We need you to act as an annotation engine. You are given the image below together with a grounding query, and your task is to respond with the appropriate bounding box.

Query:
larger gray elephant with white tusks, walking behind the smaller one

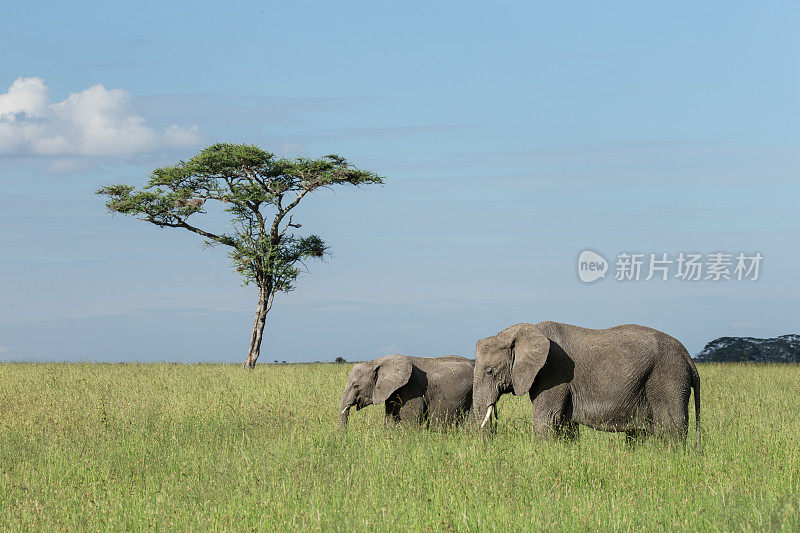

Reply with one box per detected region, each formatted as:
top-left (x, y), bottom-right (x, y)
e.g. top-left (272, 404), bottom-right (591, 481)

top-left (473, 322), bottom-right (700, 444)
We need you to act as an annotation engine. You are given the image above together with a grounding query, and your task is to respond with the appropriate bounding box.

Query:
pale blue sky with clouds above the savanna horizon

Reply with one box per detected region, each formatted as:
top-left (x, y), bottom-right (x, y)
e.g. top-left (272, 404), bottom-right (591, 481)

top-left (0, 2), bottom-right (800, 362)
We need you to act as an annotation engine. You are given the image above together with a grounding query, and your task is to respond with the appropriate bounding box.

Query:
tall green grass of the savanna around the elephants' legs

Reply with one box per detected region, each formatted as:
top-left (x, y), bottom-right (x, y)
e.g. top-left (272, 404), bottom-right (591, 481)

top-left (0, 364), bottom-right (800, 531)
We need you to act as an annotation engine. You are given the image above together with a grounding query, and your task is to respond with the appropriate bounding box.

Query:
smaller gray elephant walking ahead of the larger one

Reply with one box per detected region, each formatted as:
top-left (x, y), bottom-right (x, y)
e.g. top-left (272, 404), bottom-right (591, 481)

top-left (339, 355), bottom-right (474, 429)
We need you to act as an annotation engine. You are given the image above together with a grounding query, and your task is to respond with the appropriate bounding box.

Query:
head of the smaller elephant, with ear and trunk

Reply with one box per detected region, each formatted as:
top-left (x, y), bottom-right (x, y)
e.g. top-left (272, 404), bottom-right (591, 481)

top-left (339, 355), bottom-right (413, 429)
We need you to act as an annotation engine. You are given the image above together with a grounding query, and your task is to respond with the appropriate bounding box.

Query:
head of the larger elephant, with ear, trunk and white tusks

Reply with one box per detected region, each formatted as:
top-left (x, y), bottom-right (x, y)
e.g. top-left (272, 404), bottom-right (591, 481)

top-left (472, 324), bottom-right (550, 430)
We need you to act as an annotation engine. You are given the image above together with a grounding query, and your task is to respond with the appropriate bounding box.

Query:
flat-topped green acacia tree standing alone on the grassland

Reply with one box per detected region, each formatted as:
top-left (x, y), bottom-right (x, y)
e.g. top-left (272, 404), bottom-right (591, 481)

top-left (97, 144), bottom-right (383, 368)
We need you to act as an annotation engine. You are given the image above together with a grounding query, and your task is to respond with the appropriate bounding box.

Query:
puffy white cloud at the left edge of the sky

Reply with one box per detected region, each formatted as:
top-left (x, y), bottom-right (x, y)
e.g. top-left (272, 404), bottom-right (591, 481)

top-left (0, 78), bottom-right (200, 156)
